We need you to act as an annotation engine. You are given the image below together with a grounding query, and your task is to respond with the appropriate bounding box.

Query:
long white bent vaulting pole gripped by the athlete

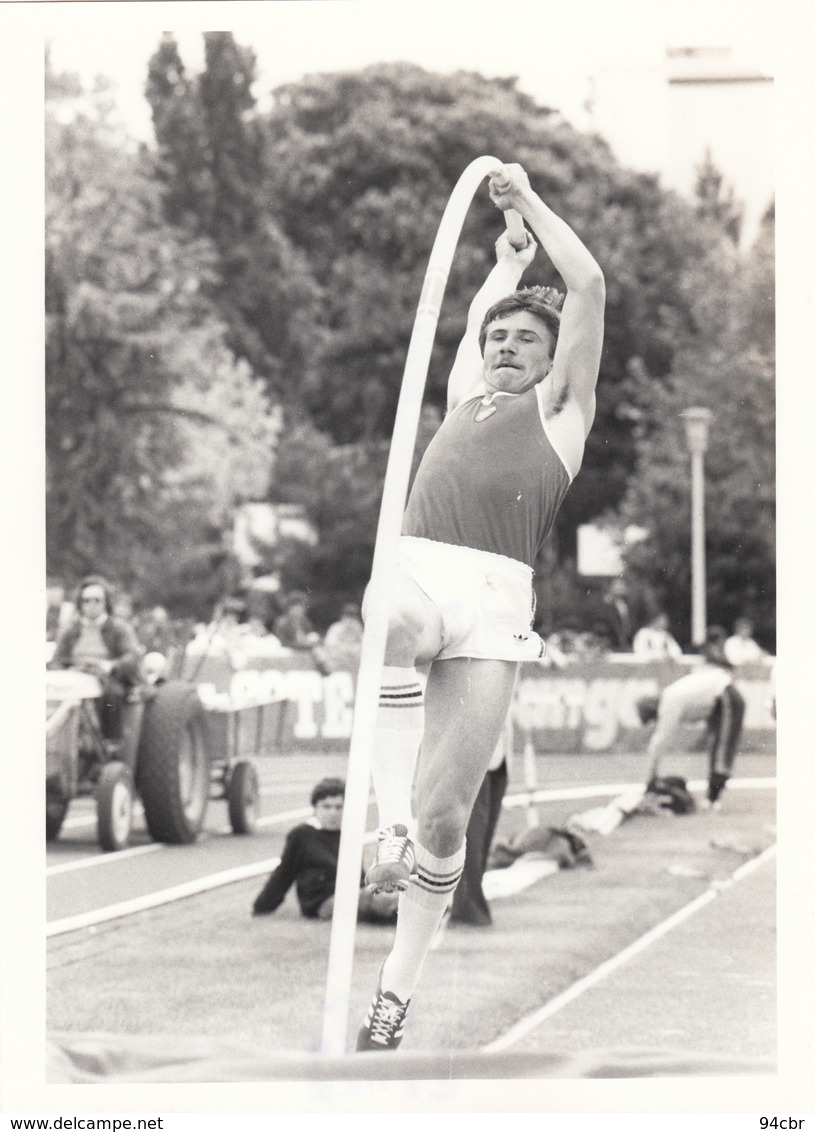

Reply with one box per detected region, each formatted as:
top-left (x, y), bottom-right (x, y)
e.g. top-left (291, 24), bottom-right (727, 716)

top-left (321, 157), bottom-right (526, 1057)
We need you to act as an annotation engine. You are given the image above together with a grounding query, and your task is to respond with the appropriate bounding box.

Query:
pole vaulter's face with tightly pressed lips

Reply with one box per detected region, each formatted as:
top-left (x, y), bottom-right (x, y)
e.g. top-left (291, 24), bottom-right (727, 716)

top-left (484, 310), bottom-right (552, 393)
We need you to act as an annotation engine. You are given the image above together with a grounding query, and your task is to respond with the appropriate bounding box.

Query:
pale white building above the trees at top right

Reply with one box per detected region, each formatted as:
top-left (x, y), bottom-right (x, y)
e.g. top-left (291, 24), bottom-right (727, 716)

top-left (590, 48), bottom-right (775, 246)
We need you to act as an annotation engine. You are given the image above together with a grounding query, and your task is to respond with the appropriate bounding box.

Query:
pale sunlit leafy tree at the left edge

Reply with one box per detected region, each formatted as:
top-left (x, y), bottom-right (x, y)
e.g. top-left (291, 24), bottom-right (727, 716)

top-left (45, 60), bottom-right (276, 611)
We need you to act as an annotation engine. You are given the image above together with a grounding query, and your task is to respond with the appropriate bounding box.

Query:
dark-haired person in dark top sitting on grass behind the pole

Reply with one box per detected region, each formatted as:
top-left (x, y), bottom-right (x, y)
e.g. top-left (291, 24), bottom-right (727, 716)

top-left (252, 778), bottom-right (398, 924)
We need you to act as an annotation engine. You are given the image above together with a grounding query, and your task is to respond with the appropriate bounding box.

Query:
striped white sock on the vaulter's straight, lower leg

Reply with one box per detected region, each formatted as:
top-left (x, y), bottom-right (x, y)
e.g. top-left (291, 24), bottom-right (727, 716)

top-left (381, 844), bottom-right (465, 1002)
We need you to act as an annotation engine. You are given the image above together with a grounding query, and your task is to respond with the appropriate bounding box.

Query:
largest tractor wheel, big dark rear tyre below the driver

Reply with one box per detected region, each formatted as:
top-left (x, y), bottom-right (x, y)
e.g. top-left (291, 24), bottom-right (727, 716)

top-left (136, 683), bottom-right (209, 844)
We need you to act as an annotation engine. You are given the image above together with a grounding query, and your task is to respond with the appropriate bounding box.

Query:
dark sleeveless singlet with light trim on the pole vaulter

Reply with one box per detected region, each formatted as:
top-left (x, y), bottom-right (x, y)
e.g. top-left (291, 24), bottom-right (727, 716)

top-left (402, 386), bottom-right (572, 568)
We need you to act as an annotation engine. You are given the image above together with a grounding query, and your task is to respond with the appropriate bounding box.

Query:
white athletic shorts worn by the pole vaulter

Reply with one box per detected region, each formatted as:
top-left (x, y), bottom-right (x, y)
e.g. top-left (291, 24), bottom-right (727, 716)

top-left (396, 535), bottom-right (544, 660)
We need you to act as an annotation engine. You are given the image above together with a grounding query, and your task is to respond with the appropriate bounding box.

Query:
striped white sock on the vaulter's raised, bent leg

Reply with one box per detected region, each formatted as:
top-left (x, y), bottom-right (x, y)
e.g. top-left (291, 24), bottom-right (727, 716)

top-left (371, 666), bottom-right (424, 831)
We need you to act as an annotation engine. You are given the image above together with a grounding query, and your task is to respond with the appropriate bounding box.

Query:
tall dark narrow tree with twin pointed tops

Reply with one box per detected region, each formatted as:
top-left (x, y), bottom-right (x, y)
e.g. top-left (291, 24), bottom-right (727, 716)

top-left (145, 32), bottom-right (316, 402)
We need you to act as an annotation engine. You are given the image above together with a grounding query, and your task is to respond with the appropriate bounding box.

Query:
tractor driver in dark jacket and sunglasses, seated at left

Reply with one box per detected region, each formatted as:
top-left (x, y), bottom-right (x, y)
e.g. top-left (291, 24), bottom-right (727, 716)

top-left (49, 574), bottom-right (144, 741)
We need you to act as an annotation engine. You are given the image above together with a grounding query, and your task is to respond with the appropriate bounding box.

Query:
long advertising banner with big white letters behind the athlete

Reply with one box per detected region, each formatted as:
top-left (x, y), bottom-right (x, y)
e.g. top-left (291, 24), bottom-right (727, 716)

top-left (182, 653), bottom-right (775, 755)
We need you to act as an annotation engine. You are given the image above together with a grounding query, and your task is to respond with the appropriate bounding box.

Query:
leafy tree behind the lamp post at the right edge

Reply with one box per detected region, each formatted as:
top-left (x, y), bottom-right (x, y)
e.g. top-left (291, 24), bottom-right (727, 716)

top-left (617, 202), bottom-right (775, 650)
